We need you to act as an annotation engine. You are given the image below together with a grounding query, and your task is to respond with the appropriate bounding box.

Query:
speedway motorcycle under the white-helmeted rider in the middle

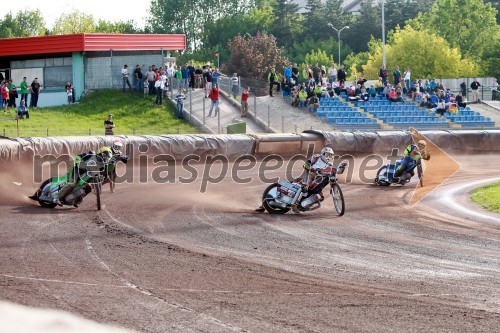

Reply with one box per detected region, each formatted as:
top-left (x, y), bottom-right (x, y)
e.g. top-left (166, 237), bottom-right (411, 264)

top-left (262, 163), bottom-right (347, 216)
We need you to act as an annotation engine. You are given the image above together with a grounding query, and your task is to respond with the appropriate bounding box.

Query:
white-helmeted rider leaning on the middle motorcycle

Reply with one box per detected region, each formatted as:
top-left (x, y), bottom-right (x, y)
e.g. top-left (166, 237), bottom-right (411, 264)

top-left (256, 147), bottom-right (334, 213)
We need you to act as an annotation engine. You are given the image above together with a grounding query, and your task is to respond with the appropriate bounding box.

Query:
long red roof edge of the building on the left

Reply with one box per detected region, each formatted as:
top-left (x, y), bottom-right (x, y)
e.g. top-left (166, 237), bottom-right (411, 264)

top-left (0, 34), bottom-right (186, 57)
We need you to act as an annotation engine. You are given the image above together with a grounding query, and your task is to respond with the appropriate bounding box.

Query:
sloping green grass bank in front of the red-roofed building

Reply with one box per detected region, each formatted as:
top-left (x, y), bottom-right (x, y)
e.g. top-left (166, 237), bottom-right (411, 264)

top-left (0, 90), bottom-right (200, 137)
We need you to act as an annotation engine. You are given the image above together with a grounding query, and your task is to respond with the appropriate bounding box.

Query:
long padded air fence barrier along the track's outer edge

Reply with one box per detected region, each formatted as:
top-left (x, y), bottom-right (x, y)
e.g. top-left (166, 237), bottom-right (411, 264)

top-left (0, 130), bottom-right (500, 164)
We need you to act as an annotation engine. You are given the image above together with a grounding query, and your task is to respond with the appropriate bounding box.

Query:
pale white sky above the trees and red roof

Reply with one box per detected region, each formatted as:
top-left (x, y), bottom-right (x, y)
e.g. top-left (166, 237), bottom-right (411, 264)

top-left (0, 0), bottom-right (151, 29)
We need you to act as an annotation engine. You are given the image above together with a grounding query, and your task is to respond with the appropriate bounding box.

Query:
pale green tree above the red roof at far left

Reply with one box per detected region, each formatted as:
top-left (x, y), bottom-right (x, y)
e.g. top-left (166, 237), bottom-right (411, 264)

top-left (0, 9), bottom-right (46, 38)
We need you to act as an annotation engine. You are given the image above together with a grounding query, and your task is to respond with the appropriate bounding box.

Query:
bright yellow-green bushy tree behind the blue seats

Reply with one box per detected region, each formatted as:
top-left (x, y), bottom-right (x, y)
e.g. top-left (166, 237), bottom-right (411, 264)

top-left (363, 26), bottom-right (479, 79)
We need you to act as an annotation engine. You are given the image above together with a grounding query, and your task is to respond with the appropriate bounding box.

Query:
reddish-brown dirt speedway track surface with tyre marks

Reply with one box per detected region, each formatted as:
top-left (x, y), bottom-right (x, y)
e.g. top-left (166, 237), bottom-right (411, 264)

top-left (0, 155), bottom-right (500, 332)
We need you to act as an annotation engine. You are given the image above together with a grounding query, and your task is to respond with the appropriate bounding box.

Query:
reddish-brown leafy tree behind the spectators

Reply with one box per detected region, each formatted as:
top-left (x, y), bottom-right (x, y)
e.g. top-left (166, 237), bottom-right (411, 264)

top-left (227, 32), bottom-right (288, 78)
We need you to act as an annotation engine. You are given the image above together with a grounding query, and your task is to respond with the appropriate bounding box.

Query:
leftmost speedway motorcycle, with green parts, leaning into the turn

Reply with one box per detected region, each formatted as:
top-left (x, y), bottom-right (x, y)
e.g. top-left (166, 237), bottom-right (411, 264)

top-left (29, 153), bottom-right (107, 210)
